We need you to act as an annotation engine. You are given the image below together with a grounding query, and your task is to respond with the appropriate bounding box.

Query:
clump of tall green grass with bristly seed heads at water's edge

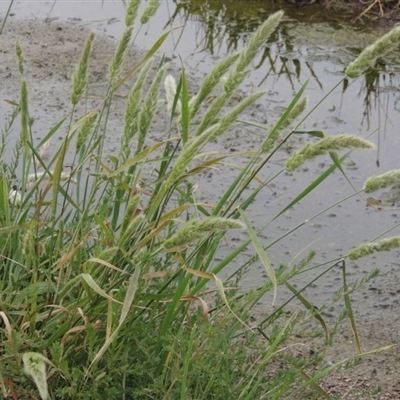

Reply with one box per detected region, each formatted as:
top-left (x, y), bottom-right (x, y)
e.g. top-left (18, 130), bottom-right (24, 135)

top-left (0, 0), bottom-right (398, 400)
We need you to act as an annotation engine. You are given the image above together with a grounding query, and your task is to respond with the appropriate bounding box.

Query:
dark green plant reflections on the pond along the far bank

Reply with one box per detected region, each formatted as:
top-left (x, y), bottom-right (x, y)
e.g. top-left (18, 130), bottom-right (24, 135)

top-left (167, 0), bottom-right (400, 141)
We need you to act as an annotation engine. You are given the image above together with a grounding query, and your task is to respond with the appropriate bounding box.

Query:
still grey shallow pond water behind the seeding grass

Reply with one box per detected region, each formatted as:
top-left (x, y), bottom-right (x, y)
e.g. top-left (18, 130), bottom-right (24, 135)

top-left (0, 0), bottom-right (400, 316)
